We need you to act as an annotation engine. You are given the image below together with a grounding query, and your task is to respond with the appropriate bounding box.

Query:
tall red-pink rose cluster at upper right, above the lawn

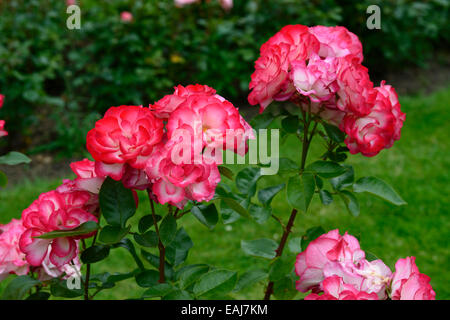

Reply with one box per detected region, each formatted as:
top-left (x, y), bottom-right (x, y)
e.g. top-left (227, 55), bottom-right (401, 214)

top-left (248, 25), bottom-right (405, 157)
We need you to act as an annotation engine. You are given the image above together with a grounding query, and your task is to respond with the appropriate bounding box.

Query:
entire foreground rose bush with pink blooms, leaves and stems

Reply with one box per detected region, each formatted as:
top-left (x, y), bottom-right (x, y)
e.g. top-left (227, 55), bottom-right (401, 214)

top-left (0, 24), bottom-right (435, 300)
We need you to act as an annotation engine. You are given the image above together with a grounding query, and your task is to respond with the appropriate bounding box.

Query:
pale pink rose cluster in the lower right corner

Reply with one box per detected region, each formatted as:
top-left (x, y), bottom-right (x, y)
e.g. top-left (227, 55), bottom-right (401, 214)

top-left (295, 230), bottom-right (436, 300)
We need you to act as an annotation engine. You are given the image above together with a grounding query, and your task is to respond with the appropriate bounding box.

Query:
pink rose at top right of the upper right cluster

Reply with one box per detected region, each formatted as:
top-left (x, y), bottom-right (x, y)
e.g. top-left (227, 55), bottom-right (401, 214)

top-left (309, 26), bottom-right (363, 63)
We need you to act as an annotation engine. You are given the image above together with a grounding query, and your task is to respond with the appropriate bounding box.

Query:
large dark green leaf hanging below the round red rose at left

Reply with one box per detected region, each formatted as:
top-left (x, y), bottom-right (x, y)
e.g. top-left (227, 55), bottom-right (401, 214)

top-left (99, 177), bottom-right (136, 228)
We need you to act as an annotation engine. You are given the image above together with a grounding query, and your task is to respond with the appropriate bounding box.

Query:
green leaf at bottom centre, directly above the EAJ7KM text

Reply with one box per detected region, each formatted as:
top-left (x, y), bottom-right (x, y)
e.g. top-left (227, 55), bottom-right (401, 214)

top-left (193, 270), bottom-right (237, 297)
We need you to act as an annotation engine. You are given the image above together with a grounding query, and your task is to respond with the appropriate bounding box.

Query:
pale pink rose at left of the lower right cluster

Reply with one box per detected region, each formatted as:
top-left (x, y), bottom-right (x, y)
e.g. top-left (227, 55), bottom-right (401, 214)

top-left (295, 229), bottom-right (365, 292)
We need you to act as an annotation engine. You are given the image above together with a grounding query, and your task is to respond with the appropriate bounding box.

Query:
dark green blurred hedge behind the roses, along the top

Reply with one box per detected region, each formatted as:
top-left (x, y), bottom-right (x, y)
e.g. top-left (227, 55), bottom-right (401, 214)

top-left (0, 0), bottom-right (450, 156)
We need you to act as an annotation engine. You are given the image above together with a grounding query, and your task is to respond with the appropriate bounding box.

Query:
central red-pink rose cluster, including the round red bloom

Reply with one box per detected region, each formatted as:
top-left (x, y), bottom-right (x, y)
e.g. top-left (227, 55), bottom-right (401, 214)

top-left (87, 84), bottom-right (253, 208)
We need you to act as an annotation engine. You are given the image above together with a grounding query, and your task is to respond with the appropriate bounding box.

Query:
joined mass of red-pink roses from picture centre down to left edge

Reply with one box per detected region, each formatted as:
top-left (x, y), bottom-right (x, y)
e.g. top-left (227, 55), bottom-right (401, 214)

top-left (0, 85), bottom-right (252, 275)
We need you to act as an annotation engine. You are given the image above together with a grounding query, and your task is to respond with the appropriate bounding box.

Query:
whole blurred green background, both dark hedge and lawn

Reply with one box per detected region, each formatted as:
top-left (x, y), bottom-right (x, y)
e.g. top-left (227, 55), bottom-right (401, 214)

top-left (0, 0), bottom-right (450, 299)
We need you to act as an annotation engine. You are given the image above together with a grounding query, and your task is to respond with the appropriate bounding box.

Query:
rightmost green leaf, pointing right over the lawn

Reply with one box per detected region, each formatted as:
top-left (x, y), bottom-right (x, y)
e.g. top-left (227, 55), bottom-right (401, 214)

top-left (353, 177), bottom-right (406, 206)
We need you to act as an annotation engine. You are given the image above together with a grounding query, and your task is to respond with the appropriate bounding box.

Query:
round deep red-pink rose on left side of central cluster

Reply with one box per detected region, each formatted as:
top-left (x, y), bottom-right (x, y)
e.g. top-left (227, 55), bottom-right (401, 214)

top-left (87, 106), bottom-right (163, 180)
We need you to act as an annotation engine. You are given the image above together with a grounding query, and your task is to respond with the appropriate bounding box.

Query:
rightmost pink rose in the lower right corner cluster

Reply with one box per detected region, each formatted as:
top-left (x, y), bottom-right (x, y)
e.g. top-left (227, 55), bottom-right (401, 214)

top-left (391, 257), bottom-right (436, 300)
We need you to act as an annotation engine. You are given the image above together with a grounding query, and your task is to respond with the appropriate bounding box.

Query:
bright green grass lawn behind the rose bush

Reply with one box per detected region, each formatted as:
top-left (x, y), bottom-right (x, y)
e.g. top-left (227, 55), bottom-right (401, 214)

top-left (0, 88), bottom-right (450, 299)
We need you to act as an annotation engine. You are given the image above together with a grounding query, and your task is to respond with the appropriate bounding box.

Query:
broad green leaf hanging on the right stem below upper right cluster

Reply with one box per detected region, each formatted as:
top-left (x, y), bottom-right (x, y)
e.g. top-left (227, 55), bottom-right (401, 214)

top-left (287, 172), bottom-right (316, 212)
